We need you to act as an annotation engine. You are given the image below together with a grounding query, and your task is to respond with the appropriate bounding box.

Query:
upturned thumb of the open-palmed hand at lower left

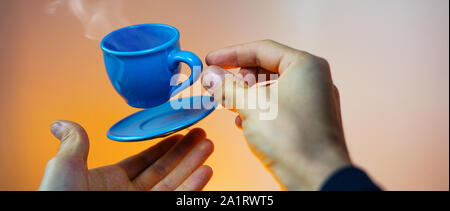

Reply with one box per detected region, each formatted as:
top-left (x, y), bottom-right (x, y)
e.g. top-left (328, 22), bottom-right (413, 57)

top-left (50, 120), bottom-right (89, 160)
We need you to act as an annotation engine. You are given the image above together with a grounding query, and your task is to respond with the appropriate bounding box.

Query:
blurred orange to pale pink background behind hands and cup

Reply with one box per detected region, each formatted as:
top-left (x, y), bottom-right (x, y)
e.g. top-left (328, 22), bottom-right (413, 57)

top-left (0, 0), bottom-right (449, 190)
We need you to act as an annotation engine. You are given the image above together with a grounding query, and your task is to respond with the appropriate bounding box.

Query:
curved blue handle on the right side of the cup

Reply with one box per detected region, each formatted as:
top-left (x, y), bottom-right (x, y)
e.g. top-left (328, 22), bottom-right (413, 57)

top-left (169, 51), bottom-right (203, 97)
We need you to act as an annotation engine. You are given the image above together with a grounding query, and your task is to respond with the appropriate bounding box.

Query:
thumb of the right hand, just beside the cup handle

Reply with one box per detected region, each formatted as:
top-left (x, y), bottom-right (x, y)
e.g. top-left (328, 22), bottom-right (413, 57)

top-left (202, 66), bottom-right (249, 117)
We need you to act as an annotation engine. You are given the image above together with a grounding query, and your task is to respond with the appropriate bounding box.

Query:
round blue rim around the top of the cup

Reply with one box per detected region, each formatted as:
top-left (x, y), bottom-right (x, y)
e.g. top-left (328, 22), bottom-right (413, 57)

top-left (100, 23), bottom-right (180, 56)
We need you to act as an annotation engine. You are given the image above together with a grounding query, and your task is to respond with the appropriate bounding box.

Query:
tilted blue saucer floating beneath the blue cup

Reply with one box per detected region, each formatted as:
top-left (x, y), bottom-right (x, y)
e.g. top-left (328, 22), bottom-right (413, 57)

top-left (107, 96), bottom-right (217, 142)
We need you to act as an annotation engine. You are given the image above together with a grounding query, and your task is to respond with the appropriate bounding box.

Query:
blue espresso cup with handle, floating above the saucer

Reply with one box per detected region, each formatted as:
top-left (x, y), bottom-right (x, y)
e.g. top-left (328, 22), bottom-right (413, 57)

top-left (100, 24), bottom-right (203, 108)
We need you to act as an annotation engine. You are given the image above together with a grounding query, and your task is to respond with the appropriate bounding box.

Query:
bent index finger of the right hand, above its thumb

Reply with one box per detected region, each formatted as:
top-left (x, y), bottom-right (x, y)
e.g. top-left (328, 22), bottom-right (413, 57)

top-left (205, 40), bottom-right (307, 74)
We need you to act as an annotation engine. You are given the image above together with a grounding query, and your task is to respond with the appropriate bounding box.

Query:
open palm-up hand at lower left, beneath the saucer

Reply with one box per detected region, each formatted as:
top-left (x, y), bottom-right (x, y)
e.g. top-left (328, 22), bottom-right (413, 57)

top-left (39, 121), bottom-right (213, 191)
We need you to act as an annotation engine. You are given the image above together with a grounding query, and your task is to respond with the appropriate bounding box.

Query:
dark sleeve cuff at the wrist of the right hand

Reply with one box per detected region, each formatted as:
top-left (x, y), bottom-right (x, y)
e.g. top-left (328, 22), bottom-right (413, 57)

top-left (320, 166), bottom-right (381, 191)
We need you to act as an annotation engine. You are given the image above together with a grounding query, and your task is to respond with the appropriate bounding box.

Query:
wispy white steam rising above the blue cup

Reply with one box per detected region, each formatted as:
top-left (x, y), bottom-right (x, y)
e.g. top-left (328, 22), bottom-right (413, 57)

top-left (46, 0), bottom-right (130, 40)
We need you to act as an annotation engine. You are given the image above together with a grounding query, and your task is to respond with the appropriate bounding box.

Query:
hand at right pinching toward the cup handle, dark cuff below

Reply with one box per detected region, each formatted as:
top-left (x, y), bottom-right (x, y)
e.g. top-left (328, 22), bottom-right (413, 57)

top-left (202, 40), bottom-right (351, 190)
